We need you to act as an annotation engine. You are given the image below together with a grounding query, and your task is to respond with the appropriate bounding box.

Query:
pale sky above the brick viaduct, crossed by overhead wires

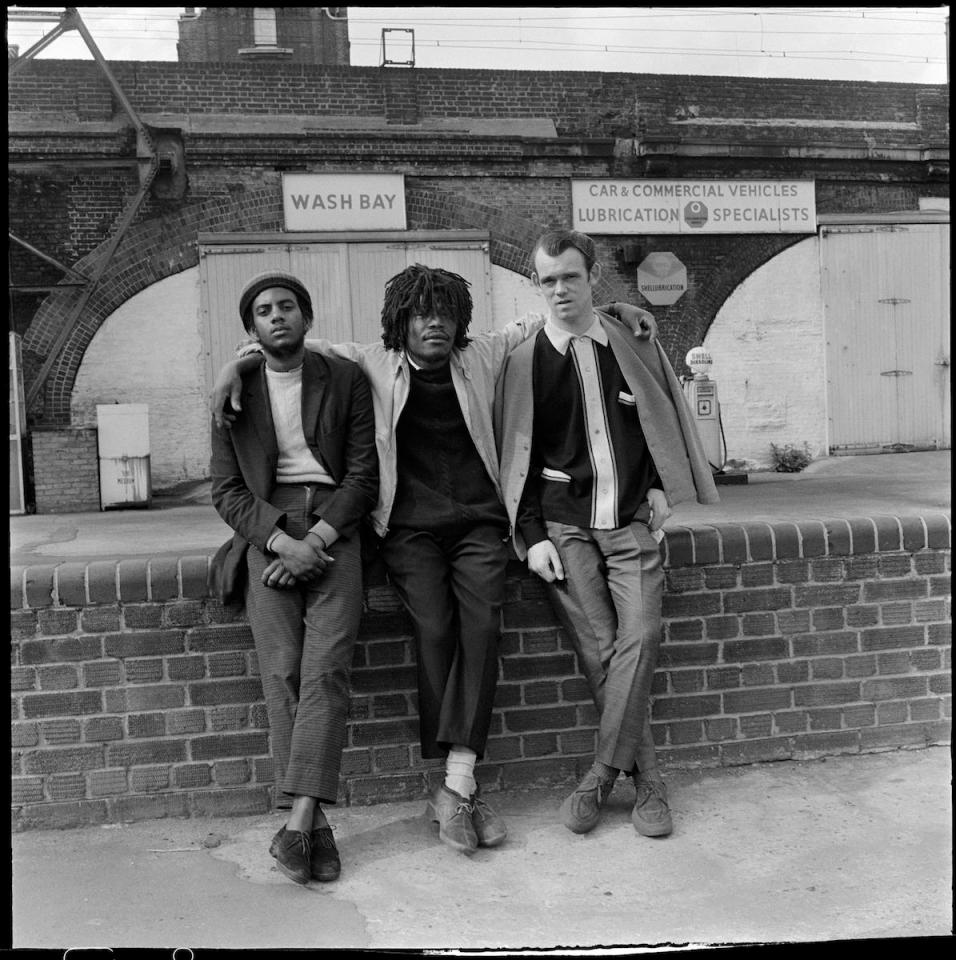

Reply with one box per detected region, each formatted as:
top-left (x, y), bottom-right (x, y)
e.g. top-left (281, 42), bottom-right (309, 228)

top-left (7, 6), bottom-right (949, 83)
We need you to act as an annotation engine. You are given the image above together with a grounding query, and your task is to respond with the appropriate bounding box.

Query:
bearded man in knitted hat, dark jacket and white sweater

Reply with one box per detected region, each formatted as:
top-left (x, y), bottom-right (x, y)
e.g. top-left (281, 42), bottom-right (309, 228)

top-left (210, 270), bottom-right (378, 883)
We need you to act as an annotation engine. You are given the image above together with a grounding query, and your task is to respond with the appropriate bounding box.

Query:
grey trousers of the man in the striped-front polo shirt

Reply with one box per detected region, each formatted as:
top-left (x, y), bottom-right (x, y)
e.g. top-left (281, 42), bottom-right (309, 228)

top-left (547, 520), bottom-right (664, 775)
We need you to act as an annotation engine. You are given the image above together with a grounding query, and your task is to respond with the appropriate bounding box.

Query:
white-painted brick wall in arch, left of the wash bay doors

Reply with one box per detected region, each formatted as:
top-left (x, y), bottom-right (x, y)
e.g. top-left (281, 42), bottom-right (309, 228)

top-left (70, 268), bottom-right (209, 490)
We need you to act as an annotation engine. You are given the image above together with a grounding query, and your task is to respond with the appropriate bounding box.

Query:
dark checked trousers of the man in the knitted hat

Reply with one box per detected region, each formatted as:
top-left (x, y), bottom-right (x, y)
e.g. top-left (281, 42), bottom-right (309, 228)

top-left (246, 485), bottom-right (362, 803)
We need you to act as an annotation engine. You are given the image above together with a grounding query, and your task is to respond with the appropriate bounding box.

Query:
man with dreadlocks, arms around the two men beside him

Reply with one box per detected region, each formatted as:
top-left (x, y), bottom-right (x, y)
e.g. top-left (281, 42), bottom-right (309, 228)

top-left (212, 263), bottom-right (656, 853)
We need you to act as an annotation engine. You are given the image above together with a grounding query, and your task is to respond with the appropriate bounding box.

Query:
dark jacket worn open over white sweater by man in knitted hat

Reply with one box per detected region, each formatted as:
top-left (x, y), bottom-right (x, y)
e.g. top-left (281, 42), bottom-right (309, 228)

top-left (210, 351), bottom-right (378, 576)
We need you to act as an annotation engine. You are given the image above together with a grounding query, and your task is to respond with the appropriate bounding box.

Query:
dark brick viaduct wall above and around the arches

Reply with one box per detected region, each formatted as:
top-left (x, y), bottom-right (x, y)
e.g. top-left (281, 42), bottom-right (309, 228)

top-left (14, 60), bottom-right (948, 427)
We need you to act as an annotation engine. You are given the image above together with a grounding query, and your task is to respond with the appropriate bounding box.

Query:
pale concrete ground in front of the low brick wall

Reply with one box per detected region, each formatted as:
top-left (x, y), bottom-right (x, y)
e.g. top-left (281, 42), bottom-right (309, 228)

top-left (12, 747), bottom-right (953, 955)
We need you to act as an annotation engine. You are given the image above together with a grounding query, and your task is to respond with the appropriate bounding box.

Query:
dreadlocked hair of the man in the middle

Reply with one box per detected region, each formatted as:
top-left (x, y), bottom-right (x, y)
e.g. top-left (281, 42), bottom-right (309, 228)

top-left (382, 263), bottom-right (472, 350)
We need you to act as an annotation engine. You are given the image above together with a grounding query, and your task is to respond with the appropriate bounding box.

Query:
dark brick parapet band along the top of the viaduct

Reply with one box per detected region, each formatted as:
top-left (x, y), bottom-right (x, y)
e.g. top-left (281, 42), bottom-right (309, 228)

top-left (8, 60), bottom-right (947, 142)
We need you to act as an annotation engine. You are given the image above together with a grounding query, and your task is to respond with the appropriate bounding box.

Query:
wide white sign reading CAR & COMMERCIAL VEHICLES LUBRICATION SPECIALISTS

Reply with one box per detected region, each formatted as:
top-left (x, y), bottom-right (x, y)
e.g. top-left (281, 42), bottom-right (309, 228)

top-left (571, 180), bottom-right (817, 234)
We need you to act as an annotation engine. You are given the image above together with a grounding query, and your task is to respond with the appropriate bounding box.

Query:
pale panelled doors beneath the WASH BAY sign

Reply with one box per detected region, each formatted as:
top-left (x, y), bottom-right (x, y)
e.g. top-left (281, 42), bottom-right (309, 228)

top-left (199, 240), bottom-right (492, 390)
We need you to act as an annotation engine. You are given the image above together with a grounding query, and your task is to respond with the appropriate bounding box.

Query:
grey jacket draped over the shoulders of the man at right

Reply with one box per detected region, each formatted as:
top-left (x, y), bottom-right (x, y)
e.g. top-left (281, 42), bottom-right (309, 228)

top-left (495, 313), bottom-right (719, 560)
